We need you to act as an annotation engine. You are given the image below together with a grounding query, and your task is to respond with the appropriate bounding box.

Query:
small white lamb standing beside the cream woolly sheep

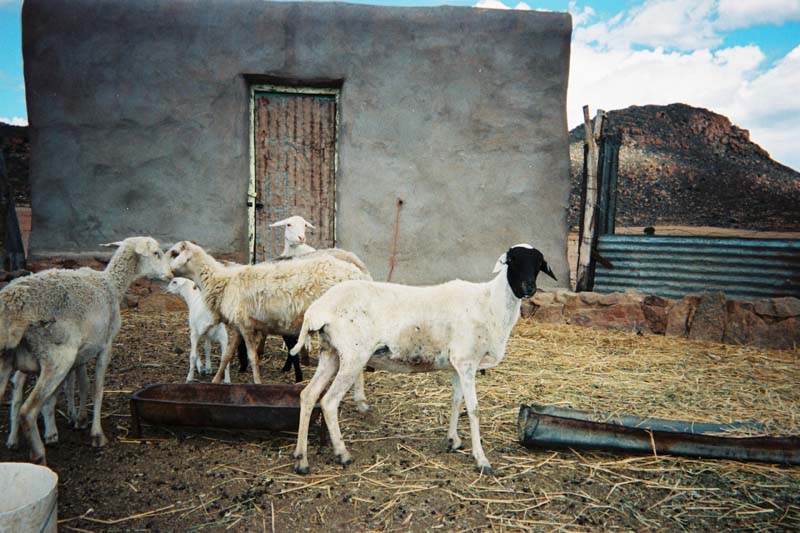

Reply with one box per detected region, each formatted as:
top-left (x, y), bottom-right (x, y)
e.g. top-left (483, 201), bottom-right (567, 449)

top-left (166, 278), bottom-right (231, 383)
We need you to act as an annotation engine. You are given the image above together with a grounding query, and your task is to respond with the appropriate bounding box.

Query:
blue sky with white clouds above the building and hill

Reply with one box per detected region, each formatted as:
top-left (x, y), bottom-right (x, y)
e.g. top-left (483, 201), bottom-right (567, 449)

top-left (0, 0), bottom-right (800, 171)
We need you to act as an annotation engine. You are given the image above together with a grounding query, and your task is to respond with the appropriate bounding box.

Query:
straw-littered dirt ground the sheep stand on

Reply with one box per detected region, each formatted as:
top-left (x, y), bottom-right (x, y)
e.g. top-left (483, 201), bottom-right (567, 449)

top-left (0, 311), bottom-right (800, 532)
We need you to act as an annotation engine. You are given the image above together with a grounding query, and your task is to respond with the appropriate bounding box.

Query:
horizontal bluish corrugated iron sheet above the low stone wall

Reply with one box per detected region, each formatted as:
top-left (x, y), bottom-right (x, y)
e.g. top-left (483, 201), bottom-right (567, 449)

top-left (594, 235), bottom-right (800, 299)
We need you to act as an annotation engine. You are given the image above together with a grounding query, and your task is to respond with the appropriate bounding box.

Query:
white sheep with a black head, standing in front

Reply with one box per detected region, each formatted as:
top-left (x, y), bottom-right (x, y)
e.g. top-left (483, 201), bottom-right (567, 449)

top-left (292, 244), bottom-right (555, 474)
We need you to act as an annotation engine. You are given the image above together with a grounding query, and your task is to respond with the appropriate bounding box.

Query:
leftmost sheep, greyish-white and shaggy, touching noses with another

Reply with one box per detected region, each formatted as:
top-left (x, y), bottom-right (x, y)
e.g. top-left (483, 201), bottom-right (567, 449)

top-left (0, 237), bottom-right (170, 464)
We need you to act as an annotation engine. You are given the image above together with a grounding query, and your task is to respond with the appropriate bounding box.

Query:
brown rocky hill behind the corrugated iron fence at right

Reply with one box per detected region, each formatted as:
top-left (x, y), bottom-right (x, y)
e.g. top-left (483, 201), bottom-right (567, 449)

top-left (569, 104), bottom-right (800, 231)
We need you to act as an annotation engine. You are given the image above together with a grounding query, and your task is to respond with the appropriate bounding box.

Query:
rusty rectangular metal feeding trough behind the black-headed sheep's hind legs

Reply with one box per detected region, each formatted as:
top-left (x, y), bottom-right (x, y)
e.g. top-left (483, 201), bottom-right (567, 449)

top-left (130, 383), bottom-right (325, 437)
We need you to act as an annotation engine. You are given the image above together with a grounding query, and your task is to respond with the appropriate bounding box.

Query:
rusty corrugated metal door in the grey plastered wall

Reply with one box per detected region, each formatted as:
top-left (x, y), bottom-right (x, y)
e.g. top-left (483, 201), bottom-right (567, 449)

top-left (253, 91), bottom-right (336, 261)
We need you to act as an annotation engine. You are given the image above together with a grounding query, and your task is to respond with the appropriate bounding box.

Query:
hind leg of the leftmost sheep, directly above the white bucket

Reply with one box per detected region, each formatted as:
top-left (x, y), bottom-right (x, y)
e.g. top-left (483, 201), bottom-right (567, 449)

top-left (19, 356), bottom-right (77, 464)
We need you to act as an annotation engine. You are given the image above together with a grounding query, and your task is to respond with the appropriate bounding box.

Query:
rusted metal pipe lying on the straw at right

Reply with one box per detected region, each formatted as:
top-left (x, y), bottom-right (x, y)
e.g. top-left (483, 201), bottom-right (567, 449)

top-left (517, 405), bottom-right (800, 465)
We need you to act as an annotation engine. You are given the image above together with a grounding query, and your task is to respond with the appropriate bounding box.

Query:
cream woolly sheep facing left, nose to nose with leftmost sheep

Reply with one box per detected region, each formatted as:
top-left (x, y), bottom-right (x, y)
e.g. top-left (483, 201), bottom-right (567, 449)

top-left (168, 241), bottom-right (372, 411)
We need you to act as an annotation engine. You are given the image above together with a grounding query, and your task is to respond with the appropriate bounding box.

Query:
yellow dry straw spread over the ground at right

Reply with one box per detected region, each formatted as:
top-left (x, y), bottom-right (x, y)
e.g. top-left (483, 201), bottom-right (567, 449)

top-left (186, 322), bottom-right (800, 531)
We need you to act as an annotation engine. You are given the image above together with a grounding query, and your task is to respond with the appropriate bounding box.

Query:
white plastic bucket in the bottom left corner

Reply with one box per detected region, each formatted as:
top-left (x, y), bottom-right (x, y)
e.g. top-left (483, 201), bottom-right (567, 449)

top-left (0, 463), bottom-right (58, 533)
